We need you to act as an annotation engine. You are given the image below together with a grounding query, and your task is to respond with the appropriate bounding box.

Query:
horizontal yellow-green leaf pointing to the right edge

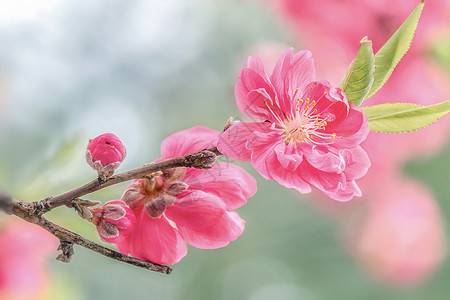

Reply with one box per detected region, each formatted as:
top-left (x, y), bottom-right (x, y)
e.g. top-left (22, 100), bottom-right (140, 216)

top-left (363, 100), bottom-right (450, 133)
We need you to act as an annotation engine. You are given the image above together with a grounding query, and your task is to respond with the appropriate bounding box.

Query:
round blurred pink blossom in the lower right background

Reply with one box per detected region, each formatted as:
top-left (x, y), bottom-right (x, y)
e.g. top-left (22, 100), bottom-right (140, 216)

top-left (349, 180), bottom-right (445, 286)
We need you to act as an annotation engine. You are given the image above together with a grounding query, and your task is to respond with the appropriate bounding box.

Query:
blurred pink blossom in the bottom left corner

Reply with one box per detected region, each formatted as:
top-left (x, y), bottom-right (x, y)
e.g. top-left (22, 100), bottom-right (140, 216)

top-left (0, 221), bottom-right (58, 300)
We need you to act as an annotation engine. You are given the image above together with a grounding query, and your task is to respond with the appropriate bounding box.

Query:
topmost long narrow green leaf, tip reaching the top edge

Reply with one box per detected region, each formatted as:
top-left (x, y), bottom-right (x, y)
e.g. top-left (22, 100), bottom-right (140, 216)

top-left (366, 1), bottom-right (424, 99)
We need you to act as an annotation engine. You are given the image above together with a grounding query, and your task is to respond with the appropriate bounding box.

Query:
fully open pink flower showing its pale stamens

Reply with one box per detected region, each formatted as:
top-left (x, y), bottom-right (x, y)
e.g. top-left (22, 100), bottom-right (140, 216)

top-left (217, 49), bottom-right (370, 201)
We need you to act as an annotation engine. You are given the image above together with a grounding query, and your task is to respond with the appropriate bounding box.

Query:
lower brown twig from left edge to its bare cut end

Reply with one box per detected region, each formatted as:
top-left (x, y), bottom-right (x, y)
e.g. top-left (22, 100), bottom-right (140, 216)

top-left (0, 191), bottom-right (172, 274)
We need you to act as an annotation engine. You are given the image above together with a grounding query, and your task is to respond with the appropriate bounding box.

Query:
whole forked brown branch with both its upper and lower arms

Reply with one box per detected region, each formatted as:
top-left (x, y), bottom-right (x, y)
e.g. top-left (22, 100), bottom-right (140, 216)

top-left (0, 147), bottom-right (221, 274)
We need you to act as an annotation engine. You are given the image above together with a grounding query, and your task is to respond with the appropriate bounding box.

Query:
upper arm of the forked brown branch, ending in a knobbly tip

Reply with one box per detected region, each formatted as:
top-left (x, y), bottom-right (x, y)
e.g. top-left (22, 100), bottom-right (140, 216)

top-left (32, 147), bottom-right (221, 215)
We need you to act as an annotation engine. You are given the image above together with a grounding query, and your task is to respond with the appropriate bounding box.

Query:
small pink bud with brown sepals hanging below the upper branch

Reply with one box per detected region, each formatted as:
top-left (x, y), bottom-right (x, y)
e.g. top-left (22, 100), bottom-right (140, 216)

top-left (91, 200), bottom-right (136, 243)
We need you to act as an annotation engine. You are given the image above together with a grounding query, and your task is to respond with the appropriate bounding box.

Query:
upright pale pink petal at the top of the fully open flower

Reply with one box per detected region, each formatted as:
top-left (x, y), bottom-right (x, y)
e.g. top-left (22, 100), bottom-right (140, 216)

top-left (270, 48), bottom-right (316, 112)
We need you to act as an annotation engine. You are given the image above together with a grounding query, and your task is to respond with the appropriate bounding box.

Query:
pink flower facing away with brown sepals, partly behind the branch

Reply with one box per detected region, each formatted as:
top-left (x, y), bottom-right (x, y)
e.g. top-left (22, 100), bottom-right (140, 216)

top-left (115, 127), bottom-right (256, 264)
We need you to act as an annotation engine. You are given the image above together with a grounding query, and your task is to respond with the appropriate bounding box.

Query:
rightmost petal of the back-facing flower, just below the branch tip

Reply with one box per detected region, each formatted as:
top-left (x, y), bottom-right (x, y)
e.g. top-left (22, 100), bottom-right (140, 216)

top-left (184, 163), bottom-right (256, 210)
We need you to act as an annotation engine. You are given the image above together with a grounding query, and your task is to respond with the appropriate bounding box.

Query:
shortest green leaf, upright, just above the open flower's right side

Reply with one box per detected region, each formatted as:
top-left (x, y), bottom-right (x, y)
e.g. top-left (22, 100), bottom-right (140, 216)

top-left (339, 37), bottom-right (374, 106)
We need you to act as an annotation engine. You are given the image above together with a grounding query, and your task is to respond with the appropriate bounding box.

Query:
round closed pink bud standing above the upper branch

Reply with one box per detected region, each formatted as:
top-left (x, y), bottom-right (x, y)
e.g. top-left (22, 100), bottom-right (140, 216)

top-left (86, 133), bottom-right (126, 179)
